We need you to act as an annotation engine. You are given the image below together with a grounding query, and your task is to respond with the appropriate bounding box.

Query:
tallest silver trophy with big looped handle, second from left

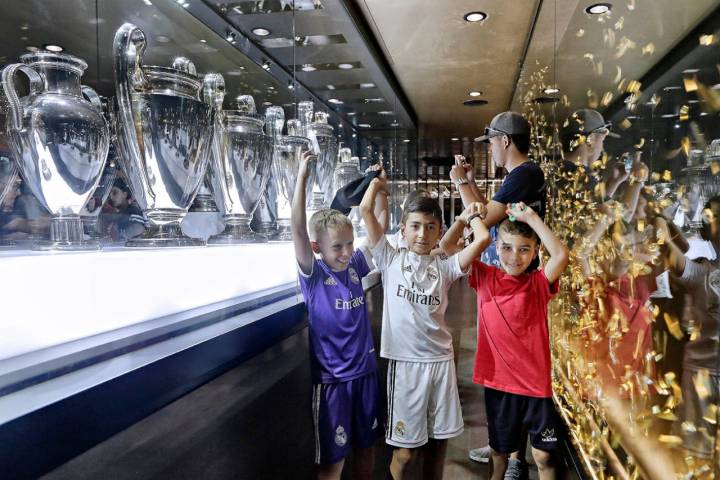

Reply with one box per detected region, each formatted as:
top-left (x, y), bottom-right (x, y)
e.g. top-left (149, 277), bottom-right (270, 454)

top-left (113, 23), bottom-right (223, 247)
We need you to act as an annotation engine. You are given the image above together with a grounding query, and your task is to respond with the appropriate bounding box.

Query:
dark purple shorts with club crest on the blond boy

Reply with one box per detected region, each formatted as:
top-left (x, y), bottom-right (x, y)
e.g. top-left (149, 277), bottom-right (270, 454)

top-left (312, 372), bottom-right (385, 465)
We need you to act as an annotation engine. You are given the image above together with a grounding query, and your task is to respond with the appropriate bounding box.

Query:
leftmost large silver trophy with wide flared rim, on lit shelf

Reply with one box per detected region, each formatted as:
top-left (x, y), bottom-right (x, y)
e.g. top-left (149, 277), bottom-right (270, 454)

top-left (2, 52), bottom-right (110, 250)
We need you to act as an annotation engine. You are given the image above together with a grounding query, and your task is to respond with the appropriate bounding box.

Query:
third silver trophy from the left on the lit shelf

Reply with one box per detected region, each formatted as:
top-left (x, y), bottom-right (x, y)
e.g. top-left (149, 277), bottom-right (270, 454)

top-left (208, 88), bottom-right (273, 244)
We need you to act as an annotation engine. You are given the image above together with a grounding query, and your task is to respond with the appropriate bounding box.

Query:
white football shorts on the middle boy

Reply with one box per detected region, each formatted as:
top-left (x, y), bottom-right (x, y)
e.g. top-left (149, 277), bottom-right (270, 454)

top-left (385, 360), bottom-right (463, 448)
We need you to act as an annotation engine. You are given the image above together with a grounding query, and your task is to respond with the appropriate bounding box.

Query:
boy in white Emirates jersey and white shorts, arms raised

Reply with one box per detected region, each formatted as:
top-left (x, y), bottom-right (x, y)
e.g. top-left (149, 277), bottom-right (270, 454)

top-left (360, 178), bottom-right (490, 480)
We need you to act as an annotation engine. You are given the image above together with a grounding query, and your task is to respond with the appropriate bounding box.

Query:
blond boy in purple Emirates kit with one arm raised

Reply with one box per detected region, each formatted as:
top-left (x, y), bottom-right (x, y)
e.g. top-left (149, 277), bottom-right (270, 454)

top-left (292, 152), bottom-right (387, 480)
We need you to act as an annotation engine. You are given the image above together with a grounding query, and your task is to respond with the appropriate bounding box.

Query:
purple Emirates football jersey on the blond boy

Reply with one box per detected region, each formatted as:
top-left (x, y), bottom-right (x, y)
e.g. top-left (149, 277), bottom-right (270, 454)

top-left (299, 250), bottom-right (377, 383)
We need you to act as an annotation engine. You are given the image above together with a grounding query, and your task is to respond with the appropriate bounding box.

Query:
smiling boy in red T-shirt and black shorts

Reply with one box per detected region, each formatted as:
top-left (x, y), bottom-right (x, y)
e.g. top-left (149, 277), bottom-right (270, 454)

top-left (469, 203), bottom-right (569, 480)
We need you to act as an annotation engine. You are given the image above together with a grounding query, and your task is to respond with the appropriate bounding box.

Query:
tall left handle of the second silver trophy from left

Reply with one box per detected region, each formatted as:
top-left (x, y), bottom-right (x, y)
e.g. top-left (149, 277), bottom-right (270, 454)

top-left (113, 23), bottom-right (155, 202)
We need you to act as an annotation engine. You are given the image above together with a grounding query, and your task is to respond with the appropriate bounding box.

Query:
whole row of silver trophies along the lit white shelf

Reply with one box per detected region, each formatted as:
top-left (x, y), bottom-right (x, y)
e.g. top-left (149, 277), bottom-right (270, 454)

top-left (2, 23), bottom-right (349, 250)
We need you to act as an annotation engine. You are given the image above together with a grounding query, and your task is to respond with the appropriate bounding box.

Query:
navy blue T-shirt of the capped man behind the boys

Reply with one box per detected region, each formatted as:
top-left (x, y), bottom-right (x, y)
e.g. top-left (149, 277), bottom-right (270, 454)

top-left (482, 161), bottom-right (547, 269)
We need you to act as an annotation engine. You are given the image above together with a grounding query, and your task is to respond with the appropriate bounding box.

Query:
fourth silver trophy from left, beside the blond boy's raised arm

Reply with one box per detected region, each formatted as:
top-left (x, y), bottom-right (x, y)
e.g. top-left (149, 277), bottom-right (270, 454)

top-left (272, 112), bottom-right (315, 241)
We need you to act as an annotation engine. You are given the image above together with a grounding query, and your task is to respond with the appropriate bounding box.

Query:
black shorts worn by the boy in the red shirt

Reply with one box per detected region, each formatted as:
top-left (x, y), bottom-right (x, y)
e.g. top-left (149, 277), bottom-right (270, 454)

top-left (485, 387), bottom-right (562, 453)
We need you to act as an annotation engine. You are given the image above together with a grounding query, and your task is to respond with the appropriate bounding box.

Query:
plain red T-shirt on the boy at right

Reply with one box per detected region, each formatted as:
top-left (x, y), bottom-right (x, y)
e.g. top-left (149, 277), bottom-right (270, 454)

top-left (469, 260), bottom-right (558, 398)
